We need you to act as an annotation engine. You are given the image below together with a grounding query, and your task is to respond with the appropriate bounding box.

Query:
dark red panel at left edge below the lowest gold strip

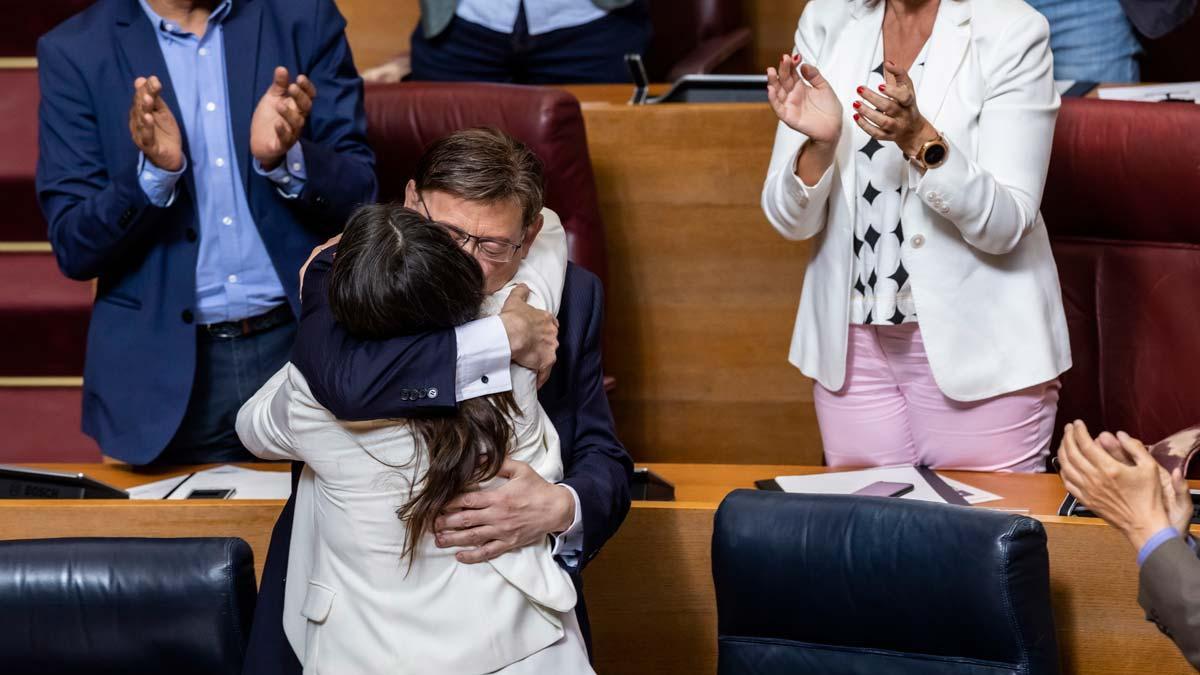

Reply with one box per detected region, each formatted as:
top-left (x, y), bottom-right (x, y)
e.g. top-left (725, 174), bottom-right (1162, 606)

top-left (0, 387), bottom-right (100, 464)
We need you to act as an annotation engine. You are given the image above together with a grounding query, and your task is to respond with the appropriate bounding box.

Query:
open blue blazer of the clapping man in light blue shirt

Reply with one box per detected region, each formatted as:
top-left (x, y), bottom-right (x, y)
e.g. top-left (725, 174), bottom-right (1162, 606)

top-left (37, 0), bottom-right (376, 464)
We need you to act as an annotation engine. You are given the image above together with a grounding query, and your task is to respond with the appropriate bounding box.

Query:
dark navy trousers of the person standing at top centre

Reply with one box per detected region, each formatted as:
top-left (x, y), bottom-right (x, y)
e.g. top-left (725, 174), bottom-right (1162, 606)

top-left (412, 1), bottom-right (650, 84)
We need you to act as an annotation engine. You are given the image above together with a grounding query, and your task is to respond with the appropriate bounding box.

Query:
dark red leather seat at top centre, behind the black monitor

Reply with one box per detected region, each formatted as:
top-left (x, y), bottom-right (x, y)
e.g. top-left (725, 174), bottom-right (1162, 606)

top-left (646, 0), bottom-right (752, 82)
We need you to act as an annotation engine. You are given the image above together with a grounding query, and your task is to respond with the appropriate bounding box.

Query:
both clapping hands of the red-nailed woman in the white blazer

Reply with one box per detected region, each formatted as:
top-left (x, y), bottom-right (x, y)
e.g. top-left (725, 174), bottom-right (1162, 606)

top-left (767, 54), bottom-right (937, 155)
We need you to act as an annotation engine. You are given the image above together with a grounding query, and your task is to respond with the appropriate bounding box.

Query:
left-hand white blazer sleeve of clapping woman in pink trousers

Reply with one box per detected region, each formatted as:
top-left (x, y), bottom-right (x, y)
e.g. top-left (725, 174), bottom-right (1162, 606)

top-left (762, 10), bottom-right (839, 239)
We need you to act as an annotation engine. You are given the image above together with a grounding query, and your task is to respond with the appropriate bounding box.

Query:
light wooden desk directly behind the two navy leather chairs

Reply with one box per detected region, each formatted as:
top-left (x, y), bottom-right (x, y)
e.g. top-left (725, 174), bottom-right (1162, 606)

top-left (0, 464), bottom-right (1193, 675)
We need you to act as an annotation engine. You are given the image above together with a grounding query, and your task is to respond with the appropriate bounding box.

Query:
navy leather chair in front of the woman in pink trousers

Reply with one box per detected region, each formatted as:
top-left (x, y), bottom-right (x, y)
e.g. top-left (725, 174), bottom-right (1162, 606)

top-left (713, 490), bottom-right (1058, 675)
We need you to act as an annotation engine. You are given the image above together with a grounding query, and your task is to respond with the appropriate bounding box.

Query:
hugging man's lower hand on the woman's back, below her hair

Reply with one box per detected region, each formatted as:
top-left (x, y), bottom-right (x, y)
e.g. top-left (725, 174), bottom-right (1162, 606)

top-left (433, 459), bottom-right (575, 563)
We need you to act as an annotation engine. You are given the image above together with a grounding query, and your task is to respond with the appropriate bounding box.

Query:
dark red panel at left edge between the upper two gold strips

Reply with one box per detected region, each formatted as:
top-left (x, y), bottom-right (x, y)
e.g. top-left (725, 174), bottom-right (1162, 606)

top-left (0, 68), bottom-right (46, 241)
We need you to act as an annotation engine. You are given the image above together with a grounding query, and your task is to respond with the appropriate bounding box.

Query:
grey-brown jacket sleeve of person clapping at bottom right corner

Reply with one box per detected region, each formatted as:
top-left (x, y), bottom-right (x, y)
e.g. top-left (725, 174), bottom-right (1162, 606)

top-left (1138, 538), bottom-right (1200, 669)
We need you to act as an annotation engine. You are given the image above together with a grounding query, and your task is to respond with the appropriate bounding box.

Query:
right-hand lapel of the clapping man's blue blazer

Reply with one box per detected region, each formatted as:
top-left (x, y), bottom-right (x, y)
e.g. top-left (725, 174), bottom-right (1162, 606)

top-left (222, 0), bottom-right (266, 197)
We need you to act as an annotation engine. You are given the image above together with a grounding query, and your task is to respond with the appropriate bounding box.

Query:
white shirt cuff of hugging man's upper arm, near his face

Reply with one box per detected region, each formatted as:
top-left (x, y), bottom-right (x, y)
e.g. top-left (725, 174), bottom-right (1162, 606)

top-left (454, 316), bottom-right (512, 401)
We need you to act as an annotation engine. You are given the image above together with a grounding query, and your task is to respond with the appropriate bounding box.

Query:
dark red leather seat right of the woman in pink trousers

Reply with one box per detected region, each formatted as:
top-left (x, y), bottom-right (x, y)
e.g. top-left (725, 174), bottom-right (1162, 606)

top-left (1042, 98), bottom-right (1200, 458)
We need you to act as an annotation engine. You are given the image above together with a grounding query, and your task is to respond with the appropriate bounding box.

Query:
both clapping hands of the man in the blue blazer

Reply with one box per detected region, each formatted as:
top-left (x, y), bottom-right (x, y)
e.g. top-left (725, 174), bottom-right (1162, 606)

top-left (130, 66), bottom-right (317, 172)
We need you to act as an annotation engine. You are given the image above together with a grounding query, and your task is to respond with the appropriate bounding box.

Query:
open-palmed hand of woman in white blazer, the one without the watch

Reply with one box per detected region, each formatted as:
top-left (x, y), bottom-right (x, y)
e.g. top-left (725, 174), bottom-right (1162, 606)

top-left (767, 54), bottom-right (842, 145)
